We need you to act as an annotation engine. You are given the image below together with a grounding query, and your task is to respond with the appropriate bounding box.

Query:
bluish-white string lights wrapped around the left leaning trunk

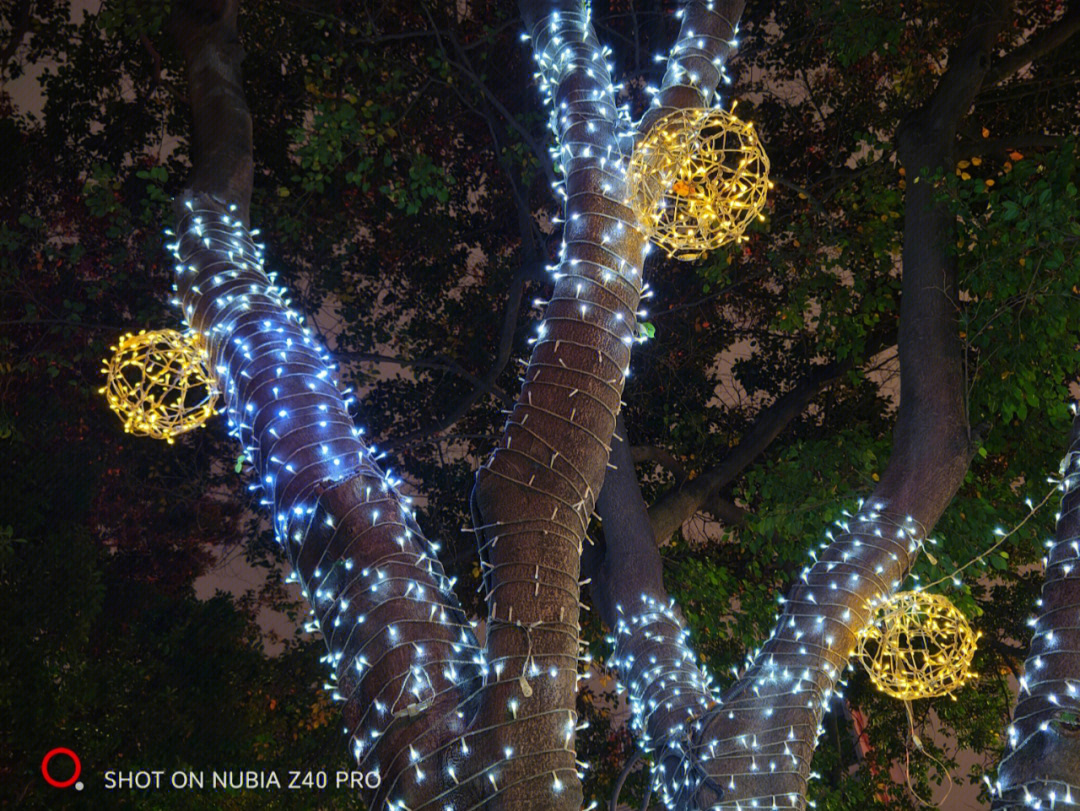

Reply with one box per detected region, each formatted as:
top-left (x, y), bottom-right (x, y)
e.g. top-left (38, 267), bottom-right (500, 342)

top-left (170, 199), bottom-right (509, 808)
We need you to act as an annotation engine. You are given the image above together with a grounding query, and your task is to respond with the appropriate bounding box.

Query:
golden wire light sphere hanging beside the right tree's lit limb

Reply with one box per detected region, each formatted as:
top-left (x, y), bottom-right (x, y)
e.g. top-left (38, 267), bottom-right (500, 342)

top-left (855, 592), bottom-right (980, 701)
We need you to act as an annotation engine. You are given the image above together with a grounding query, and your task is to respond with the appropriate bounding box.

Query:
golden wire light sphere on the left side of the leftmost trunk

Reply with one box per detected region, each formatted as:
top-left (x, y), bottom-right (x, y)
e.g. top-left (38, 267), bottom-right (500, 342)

top-left (100, 329), bottom-right (218, 444)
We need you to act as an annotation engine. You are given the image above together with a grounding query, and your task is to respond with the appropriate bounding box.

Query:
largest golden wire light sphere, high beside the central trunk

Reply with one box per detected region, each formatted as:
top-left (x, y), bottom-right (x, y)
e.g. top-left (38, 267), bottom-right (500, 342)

top-left (627, 105), bottom-right (772, 260)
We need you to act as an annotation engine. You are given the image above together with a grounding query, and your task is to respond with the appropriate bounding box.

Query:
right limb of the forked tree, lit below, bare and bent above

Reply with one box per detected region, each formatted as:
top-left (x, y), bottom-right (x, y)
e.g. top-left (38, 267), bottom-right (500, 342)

top-left (684, 0), bottom-right (1005, 809)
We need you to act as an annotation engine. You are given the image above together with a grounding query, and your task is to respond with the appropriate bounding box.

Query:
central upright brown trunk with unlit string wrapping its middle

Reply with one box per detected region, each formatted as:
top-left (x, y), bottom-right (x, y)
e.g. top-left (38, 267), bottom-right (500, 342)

top-left (474, 0), bottom-right (645, 809)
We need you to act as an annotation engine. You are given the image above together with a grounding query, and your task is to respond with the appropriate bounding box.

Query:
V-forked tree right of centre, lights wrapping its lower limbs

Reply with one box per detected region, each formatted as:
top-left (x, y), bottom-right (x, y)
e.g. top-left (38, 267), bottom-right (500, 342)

top-left (598, 2), bottom-right (1005, 810)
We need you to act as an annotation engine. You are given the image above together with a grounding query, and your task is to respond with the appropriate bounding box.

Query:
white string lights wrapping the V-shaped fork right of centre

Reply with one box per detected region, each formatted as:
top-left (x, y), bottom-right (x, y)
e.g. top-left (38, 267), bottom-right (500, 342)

top-left (609, 503), bottom-right (923, 811)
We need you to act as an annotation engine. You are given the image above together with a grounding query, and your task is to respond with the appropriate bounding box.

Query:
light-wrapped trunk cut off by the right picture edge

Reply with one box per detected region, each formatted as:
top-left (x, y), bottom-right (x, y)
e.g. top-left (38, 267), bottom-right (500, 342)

top-left (993, 417), bottom-right (1080, 811)
